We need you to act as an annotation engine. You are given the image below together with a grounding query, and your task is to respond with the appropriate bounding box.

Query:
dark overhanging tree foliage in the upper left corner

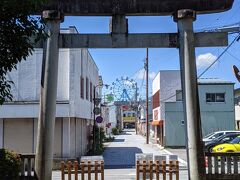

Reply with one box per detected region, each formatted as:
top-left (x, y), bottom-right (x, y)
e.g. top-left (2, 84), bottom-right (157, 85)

top-left (0, 0), bottom-right (46, 104)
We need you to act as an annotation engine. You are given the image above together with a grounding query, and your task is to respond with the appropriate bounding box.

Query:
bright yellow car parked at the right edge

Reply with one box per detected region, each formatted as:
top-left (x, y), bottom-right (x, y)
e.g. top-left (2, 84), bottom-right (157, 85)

top-left (212, 136), bottom-right (240, 152)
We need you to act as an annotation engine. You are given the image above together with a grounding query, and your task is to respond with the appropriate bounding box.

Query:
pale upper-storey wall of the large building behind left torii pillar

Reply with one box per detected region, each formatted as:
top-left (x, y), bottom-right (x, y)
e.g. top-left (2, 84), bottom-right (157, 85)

top-left (0, 49), bottom-right (98, 119)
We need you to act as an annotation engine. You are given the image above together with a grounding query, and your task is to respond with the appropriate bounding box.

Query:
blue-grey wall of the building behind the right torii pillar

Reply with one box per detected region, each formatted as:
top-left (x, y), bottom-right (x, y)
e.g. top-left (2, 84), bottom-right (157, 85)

top-left (165, 84), bottom-right (235, 146)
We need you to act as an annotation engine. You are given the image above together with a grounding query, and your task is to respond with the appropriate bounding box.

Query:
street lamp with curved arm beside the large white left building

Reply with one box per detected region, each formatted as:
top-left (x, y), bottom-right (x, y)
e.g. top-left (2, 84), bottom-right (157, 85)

top-left (93, 83), bottom-right (109, 154)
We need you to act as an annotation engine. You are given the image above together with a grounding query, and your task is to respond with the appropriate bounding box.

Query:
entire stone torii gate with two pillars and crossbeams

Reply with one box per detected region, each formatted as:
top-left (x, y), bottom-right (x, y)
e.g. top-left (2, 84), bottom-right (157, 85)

top-left (35, 0), bottom-right (234, 180)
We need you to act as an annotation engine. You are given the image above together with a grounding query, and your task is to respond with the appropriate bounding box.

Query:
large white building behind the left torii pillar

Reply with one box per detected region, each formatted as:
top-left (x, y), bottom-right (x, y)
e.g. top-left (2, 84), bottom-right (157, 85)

top-left (0, 27), bottom-right (99, 158)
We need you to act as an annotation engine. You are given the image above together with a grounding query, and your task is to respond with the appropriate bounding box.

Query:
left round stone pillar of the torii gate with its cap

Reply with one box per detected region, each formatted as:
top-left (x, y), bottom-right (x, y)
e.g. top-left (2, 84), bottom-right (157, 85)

top-left (35, 10), bottom-right (63, 180)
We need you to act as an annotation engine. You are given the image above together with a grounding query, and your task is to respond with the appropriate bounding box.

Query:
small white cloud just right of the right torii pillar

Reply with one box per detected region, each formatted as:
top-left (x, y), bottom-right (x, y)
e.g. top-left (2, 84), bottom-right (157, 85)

top-left (196, 53), bottom-right (217, 69)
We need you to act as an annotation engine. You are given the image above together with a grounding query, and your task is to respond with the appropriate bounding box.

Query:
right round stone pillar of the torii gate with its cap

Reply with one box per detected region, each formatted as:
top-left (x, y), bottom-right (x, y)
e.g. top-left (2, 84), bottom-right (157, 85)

top-left (174, 9), bottom-right (206, 180)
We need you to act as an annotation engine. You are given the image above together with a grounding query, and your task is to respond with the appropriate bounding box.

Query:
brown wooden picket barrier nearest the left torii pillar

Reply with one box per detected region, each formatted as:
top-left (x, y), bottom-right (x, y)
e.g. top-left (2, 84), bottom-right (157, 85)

top-left (61, 161), bottom-right (104, 180)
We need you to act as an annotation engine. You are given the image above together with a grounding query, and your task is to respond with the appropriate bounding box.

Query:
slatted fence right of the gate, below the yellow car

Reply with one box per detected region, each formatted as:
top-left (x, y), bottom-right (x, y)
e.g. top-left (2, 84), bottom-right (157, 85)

top-left (205, 152), bottom-right (240, 180)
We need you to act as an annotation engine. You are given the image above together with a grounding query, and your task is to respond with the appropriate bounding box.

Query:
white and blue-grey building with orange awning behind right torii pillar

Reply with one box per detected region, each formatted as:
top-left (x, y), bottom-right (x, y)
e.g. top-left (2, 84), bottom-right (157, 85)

top-left (152, 70), bottom-right (235, 146)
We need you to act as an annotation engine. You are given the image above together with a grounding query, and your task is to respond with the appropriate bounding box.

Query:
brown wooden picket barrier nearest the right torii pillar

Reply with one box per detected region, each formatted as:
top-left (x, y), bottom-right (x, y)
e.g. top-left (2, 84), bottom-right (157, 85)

top-left (136, 160), bottom-right (179, 180)
